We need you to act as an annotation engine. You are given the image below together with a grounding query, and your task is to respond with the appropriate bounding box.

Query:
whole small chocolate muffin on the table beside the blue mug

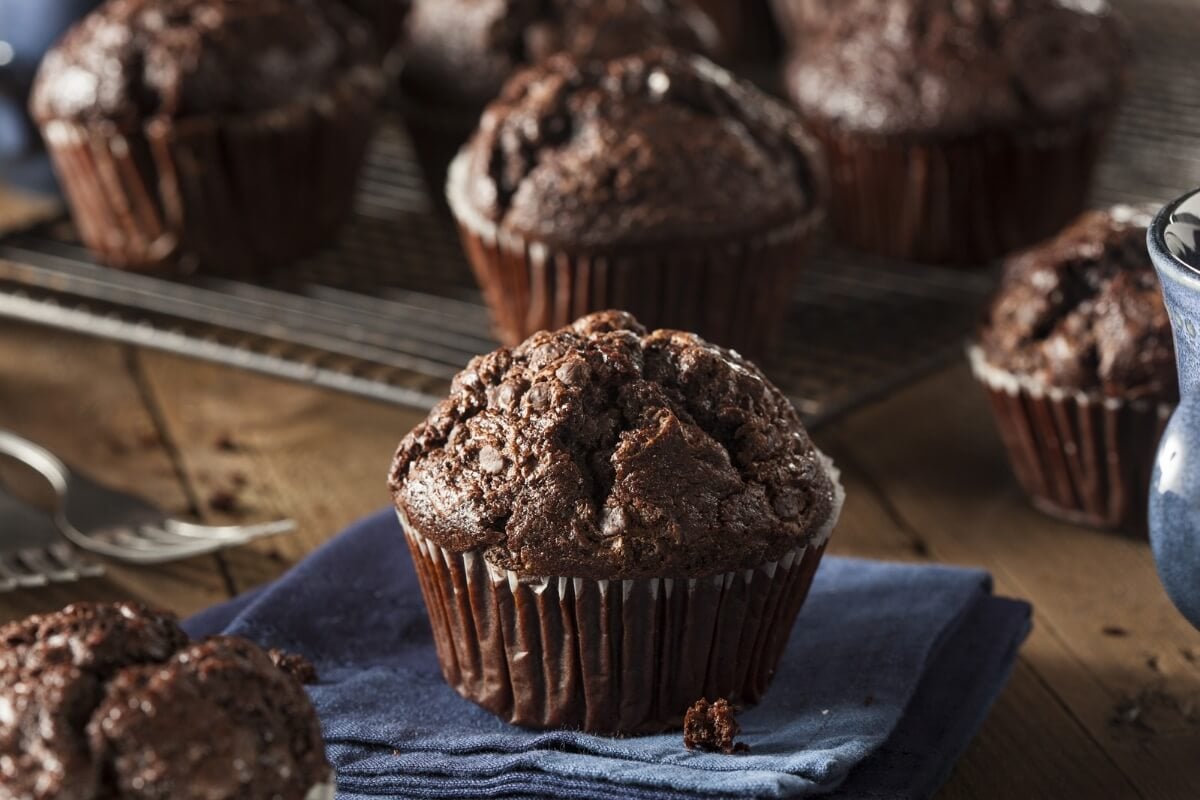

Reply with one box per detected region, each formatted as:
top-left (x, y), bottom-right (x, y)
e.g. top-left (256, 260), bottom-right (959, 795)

top-left (971, 206), bottom-right (1178, 531)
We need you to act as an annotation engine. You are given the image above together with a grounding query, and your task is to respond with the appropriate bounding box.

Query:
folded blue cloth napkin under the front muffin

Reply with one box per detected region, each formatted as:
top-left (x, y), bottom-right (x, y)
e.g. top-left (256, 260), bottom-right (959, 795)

top-left (185, 511), bottom-right (1030, 800)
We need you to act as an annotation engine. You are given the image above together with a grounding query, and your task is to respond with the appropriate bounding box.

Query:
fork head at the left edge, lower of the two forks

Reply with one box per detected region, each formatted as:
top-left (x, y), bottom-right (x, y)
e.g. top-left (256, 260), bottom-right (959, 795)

top-left (0, 488), bottom-right (104, 593)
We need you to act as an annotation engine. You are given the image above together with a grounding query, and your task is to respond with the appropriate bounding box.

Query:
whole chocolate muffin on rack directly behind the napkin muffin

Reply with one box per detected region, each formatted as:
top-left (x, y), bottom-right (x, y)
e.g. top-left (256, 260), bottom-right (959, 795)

top-left (446, 49), bottom-right (824, 355)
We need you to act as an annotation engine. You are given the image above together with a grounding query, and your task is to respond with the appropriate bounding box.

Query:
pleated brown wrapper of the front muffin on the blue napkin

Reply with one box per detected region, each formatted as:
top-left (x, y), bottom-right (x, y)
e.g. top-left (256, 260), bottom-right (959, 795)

top-left (400, 453), bottom-right (845, 735)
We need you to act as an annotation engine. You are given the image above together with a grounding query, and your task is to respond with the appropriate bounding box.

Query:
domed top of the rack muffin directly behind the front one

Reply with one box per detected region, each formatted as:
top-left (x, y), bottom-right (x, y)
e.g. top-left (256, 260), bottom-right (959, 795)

top-left (448, 49), bottom-right (823, 248)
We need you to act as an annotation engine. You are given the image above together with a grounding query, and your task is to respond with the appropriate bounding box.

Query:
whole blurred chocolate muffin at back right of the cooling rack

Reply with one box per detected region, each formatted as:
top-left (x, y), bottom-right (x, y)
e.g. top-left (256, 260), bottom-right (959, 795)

top-left (787, 0), bottom-right (1129, 264)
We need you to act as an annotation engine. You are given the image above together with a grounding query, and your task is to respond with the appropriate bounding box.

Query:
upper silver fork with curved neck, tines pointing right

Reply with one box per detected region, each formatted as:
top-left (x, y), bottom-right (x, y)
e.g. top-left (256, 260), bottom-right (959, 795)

top-left (0, 431), bottom-right (295, 564)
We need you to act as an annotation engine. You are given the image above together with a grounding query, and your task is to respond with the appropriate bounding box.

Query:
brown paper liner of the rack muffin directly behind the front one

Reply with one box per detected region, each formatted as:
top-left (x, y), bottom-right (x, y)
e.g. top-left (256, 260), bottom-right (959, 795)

top-left (446, 154), bottom-right (823, 356)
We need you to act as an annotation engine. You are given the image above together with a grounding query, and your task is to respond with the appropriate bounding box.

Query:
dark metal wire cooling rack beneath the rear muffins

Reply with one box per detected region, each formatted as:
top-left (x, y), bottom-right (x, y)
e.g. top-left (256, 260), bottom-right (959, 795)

top-left (0, 0), bottom-right (1200, 425)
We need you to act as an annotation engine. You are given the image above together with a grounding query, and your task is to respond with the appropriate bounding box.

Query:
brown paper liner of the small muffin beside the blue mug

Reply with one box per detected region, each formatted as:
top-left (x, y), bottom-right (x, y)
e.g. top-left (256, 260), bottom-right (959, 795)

top-left (968, 347), bottom-right (1174, 536)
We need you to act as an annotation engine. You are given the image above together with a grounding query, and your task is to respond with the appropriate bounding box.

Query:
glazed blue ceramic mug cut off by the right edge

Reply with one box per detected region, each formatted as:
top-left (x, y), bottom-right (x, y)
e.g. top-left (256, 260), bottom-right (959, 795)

top-left (1150, 190), bottom-right (1200, 627)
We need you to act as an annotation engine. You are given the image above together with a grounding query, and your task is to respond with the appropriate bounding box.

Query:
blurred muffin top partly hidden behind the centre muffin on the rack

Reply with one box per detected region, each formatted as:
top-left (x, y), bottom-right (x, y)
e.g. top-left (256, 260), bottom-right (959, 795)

top-left (403, 0), bottom-right (719, 110)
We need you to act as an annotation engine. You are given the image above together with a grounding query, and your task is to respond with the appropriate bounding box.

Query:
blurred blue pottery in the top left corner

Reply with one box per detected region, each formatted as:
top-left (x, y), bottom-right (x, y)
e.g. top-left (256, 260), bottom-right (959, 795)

top-left (0, 0), bottom-right (100, 191)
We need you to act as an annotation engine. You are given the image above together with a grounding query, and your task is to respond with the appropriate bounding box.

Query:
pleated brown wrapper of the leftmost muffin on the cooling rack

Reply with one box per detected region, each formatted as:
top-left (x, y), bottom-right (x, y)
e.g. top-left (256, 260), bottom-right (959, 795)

top-left (41, 67), bottom-right (383, 277)
